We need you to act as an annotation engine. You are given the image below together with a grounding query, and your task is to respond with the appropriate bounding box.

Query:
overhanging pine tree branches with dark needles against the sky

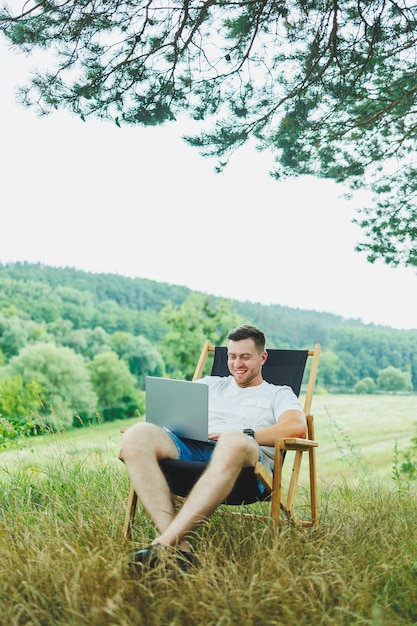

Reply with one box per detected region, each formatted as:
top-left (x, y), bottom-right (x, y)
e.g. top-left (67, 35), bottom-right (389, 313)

top-left (0, 0), bottom-right (417, 265)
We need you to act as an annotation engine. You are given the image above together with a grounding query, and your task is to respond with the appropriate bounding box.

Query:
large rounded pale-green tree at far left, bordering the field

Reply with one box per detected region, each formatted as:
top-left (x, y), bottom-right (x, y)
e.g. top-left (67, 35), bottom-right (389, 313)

top-left (1, 343), bottom-right (97, 429)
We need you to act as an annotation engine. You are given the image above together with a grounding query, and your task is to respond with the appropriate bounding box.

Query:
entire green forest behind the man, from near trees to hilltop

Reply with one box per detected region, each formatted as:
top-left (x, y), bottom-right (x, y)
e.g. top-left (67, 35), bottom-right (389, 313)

top-left (0, 263), bottom-right (417, 445)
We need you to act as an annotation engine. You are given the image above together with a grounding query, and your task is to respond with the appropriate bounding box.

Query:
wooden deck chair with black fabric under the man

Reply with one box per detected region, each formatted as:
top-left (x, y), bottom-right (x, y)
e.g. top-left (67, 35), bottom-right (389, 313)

top-left (122, 340), bottom-right (320, 539)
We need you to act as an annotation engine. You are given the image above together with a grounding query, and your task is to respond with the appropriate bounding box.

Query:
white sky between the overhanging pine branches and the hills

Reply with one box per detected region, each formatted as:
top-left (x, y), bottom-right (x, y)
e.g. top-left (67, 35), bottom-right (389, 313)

top-left (0, 41), bottom-right (417, 328)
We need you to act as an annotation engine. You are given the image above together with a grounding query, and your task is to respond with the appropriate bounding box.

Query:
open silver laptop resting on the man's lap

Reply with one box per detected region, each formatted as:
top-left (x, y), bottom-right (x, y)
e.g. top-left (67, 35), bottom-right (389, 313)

top-left (146, 376), bottom-right (208, 441)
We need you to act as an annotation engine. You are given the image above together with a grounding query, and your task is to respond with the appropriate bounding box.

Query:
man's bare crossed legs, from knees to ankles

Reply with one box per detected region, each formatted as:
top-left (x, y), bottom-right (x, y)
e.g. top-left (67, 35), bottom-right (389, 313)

top-left (121, 422), bottom-right (259, 552)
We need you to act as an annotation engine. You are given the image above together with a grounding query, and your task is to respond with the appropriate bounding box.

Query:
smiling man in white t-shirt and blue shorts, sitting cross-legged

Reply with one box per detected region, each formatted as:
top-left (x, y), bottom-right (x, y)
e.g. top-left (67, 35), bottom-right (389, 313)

top-left (121, 325), bottom-right (306, 566)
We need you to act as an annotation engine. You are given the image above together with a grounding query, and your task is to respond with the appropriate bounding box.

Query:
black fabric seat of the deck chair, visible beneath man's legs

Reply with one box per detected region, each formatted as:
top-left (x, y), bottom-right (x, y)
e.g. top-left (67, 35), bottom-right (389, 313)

top-left (159, 459), bottom-right (270, 504)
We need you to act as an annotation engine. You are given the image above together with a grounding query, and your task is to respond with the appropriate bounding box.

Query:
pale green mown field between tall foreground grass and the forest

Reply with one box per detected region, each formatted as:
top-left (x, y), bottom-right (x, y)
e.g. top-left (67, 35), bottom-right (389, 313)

top-left (0, 394), bottom-right (417, 485)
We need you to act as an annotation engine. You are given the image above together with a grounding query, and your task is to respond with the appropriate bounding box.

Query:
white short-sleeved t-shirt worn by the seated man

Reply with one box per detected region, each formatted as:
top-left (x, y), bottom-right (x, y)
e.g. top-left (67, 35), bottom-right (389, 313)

top-left (196, 376), bottom-right (303, 466)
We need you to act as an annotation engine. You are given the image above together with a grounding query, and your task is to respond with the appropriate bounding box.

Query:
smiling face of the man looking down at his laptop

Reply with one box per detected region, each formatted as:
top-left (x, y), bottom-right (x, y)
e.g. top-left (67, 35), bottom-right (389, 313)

top-left (227, 339), bottom-right (267, 387)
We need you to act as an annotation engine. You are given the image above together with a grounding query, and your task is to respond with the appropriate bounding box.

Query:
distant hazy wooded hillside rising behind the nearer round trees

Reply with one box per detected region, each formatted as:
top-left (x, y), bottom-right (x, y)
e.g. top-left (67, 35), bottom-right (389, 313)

top-left (0, 263), bottom-right (417, 390)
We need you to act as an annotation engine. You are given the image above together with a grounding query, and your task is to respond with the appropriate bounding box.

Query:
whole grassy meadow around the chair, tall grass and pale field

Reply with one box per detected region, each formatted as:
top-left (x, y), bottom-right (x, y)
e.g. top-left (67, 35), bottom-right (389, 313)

top-left (0, 395), bottom-right (417, 626)
